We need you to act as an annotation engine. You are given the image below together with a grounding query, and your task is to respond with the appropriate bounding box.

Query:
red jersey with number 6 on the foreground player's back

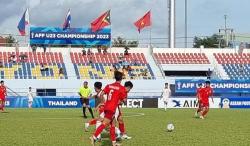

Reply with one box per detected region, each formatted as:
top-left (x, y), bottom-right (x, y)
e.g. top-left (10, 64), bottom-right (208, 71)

top-left (103, 82), bottom-right (127, 113)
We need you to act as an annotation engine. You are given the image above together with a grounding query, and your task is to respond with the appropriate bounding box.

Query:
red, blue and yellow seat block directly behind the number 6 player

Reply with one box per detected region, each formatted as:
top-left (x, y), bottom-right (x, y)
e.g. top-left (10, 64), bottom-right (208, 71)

top-left (70, 52), bottom-right (155, 79)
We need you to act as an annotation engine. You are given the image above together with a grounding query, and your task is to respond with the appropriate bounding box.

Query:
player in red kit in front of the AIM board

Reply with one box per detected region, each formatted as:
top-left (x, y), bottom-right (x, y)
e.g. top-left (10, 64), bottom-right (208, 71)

top-left (200, 81), bottom-right (214, 119)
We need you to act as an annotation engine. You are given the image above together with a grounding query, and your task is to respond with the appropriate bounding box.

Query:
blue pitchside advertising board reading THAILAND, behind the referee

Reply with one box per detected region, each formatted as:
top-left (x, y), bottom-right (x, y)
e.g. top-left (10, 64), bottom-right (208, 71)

top-left (5, 96), bottom-right (95, 108)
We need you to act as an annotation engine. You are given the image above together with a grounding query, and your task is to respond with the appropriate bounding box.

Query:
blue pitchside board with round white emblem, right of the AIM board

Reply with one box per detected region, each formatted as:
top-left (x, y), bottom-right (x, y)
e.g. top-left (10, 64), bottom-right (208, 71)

top-left (221, 97), bottom-right (250, 108)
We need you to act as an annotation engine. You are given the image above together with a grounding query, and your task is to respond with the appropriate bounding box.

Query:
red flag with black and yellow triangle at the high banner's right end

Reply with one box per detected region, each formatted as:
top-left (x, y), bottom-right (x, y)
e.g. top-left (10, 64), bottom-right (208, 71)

top-left (91, 10), bottom-right (111, 32)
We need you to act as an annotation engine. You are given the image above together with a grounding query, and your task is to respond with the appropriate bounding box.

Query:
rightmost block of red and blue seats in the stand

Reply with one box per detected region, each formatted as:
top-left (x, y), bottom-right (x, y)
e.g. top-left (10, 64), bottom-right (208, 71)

top-left (213, 53), bottom-right (250, 80)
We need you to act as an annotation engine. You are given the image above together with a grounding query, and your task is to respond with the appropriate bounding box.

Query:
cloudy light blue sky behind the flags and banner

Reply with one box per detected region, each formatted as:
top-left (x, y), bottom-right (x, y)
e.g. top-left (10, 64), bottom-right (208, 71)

top-left (0, 0), bottom-right (250, 46)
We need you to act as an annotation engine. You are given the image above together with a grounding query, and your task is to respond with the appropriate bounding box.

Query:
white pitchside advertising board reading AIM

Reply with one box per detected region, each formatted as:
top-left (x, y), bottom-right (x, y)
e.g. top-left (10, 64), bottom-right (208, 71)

top-left (158, 97), bottom-right (221, 108)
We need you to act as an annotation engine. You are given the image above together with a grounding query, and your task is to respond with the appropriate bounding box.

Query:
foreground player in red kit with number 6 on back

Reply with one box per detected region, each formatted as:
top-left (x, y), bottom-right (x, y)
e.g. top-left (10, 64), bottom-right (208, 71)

top-left (90, 71), bottom-right (132, 146)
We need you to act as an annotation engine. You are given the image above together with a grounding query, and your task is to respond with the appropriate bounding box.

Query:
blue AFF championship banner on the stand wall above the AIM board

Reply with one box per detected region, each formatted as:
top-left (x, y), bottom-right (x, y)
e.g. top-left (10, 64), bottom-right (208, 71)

top-left (175, 79), bottom-right (250, 93)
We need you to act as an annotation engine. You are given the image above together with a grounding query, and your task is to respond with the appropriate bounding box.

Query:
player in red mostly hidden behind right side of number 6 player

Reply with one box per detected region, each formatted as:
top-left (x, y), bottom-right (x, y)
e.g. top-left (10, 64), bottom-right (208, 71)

top-left (116, 81), bottom-right (133, 139)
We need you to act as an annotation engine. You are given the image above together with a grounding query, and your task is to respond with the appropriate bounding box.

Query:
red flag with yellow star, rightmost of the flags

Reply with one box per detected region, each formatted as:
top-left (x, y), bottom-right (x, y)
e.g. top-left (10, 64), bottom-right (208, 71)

top-left (134, 11), bottom-right (151, 33)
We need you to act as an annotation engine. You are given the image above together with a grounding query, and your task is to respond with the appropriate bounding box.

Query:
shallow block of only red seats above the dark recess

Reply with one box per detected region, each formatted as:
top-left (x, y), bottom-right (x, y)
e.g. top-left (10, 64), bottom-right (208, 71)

top-left (154, 53), bottom-right (210, 64)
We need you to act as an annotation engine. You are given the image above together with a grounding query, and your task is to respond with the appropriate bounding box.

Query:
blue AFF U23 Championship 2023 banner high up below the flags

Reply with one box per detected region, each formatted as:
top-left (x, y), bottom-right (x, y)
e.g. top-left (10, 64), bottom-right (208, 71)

top-left (30, 27), bottom-right (111, 46)
